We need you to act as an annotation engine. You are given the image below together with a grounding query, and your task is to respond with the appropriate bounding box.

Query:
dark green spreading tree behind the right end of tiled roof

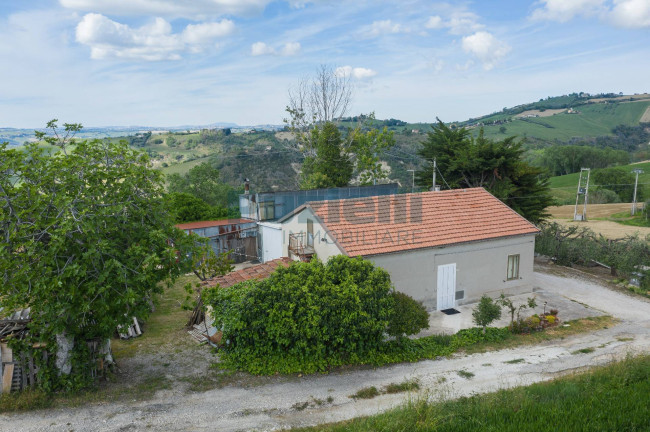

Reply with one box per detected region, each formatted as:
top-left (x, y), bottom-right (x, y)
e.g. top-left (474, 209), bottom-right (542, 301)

top-left (416, 120), bottom-right (553, 222)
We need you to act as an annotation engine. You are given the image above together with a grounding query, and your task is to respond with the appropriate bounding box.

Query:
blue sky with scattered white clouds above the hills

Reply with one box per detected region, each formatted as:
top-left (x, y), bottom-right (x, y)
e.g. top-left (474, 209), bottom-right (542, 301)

top-left (0, 0), bottom-right (650, 128)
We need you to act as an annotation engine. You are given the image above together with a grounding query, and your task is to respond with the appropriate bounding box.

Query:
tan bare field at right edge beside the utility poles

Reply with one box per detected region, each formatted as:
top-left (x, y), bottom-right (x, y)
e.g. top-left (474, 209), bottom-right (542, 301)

top-left (548, 203), bottom-right (650, 239)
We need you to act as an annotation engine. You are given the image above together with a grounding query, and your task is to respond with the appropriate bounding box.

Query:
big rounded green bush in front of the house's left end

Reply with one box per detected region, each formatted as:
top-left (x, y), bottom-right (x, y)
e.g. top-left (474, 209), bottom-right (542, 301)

top-left (204, 255), bottom-right (395, 374)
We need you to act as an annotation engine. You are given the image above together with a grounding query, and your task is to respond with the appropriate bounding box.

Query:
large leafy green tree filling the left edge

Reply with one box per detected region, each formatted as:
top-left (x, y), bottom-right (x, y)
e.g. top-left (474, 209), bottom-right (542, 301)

top-left (0, 121), bottom-right (195, 384)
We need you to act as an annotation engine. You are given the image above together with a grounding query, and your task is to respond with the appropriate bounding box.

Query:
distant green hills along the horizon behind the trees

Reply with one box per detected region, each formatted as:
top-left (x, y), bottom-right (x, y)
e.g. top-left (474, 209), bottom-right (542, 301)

top-left (6, 93), bottom-right (650, 198)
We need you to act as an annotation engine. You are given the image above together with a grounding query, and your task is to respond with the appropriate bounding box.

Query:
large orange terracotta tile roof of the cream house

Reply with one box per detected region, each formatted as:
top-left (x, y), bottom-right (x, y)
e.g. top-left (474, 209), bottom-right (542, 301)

top-left (308, 188), bottom-right (539, 256)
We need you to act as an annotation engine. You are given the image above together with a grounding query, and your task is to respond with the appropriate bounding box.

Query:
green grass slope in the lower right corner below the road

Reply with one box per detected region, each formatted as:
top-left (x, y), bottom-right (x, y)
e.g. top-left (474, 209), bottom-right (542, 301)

top-left (298, 355), bottom-right (650, 432)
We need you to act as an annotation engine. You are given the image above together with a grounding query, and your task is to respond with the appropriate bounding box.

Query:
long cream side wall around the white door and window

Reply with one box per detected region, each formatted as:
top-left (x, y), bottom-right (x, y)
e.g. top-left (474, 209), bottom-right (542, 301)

top-left (367, 234), bottom-right (535, 310)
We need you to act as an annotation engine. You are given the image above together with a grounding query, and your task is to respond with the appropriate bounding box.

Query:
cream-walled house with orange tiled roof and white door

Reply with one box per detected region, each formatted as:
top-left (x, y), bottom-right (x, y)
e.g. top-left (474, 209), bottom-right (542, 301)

top-left (278, 188), bottom-right (539, 310)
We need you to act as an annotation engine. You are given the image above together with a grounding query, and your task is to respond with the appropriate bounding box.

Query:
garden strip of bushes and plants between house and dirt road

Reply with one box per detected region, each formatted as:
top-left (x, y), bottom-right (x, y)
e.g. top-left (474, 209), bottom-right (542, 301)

top-left (203, 256), bottom-right (611, 375)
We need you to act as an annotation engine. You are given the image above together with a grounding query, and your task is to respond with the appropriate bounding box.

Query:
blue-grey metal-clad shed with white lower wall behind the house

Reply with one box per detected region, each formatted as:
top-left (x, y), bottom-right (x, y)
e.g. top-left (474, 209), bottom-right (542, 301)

top-left (239, 181), bottom-right (399, 262)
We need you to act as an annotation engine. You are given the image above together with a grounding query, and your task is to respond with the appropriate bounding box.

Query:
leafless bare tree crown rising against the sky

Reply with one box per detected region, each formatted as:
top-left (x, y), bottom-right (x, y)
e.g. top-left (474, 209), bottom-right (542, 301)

top-left (285, 65), bottom-right (353, 138)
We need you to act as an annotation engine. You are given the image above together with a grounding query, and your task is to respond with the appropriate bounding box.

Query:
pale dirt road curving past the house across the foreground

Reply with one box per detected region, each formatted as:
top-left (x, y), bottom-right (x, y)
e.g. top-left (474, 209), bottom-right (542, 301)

top-left (0, 270), bottom-right (650, 431)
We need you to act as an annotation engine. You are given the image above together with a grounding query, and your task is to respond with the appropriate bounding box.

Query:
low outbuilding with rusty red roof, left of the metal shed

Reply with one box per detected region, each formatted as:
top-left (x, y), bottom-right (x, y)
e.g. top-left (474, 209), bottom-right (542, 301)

top-left (176, 219), bottom-right (257, 263)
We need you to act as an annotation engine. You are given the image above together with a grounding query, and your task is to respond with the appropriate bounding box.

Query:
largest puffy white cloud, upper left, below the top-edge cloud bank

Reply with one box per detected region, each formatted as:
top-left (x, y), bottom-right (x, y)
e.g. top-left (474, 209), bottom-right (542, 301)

top-left (76, 13), bottom-right (234, 61)
